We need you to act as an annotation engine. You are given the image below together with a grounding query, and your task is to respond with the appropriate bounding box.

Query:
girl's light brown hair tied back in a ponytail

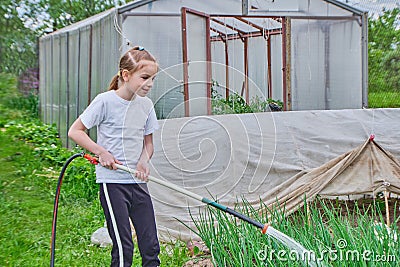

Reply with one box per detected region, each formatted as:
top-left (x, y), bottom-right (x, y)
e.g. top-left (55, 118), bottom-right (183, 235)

top-left (108, 46), bottom-right (157, 90)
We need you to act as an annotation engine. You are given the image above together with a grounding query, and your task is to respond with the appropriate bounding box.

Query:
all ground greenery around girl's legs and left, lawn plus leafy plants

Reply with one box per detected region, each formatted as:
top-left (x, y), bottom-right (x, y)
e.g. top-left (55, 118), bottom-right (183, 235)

top-left (0, 74), bottom-right (189, 267)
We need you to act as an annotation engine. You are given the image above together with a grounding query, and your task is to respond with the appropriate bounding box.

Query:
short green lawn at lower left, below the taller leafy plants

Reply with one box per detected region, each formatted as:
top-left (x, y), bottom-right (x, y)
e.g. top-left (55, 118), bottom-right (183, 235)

top-left (0, 132), bottom-right (109, 266)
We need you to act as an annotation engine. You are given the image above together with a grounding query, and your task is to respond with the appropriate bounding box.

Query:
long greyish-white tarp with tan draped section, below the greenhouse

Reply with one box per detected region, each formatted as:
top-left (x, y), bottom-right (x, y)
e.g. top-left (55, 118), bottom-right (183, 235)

top-left (149, 109), bottom-right (400, 240)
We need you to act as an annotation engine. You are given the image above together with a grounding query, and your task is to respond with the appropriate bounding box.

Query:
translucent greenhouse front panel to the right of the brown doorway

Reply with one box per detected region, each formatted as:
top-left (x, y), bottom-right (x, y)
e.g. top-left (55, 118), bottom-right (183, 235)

top-left (291, 20), bottom-right (362, 110)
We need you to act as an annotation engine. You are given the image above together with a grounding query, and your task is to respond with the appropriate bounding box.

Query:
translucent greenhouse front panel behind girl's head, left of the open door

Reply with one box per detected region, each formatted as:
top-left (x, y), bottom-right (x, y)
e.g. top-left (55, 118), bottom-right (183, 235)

top-left (121, 16), bottom-right (184, 119)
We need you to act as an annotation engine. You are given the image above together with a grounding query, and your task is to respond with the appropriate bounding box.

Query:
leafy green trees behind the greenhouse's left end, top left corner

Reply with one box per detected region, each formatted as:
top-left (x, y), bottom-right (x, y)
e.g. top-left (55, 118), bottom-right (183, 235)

top-left (0, 0), bottom-right (130, 74)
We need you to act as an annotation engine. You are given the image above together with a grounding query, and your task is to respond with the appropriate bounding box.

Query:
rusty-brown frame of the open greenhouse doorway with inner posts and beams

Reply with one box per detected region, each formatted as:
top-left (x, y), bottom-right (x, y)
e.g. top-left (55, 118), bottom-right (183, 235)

top-left (181, 7), bottom-right (291, 111)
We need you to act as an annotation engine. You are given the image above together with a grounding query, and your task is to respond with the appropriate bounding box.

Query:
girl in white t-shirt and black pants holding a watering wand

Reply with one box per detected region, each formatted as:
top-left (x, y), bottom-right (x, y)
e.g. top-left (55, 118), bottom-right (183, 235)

top-left (68, 47), bottom-right (160, 267)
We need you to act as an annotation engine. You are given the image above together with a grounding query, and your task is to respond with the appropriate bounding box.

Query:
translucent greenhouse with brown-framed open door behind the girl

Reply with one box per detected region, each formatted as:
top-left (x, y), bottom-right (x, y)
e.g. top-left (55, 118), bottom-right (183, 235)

top-left (40, 0), bottom-right (367, 146)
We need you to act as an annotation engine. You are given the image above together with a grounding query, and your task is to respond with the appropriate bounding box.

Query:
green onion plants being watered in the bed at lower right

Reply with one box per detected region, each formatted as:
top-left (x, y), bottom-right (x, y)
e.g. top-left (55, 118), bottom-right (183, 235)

top-left (192, 198), bottom-right (400, 267)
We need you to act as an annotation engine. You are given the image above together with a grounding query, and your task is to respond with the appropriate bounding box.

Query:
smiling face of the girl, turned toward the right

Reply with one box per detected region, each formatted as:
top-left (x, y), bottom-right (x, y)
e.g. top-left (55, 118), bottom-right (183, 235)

top-left (125, 60), bottom-right (158, 96)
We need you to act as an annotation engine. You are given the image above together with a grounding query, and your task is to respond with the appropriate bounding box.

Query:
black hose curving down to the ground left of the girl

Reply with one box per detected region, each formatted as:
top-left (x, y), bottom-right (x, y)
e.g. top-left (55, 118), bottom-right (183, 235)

top-left (50, 153), bottom-right (84, 267)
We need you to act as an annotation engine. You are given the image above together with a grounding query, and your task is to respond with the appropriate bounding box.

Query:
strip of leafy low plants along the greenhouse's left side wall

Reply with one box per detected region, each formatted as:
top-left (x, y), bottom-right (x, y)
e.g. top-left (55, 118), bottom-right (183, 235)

top-left (0, 73), bottom-right (98, 201)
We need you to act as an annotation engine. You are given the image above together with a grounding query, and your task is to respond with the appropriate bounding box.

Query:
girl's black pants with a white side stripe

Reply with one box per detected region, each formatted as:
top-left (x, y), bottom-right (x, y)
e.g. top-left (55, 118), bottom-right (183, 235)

top-left (100, 183), bottom-right (160, 267)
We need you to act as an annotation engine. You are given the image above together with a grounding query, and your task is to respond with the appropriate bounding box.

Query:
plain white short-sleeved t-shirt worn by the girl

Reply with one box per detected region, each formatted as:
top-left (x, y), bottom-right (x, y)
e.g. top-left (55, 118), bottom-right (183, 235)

top-left (80, 90), bottom-right (158, 184)
